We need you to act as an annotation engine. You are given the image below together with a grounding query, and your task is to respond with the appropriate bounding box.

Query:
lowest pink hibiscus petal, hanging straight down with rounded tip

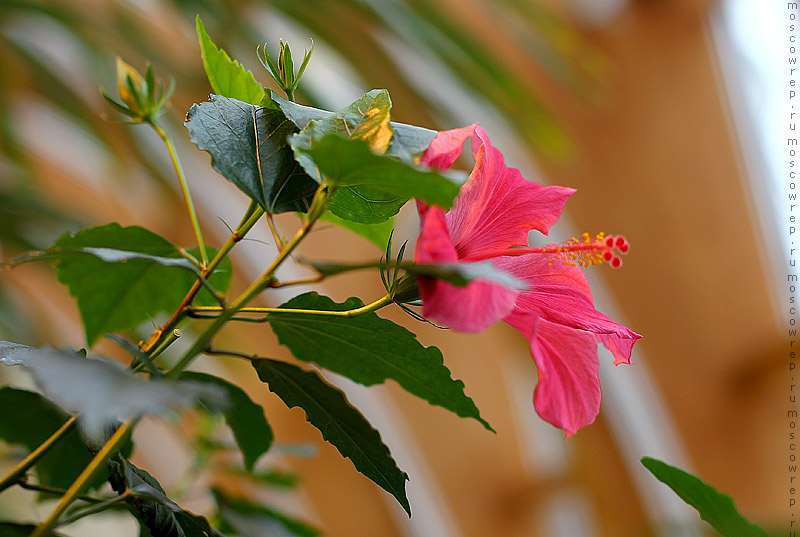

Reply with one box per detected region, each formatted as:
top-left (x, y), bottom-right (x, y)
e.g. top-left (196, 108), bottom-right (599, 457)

top-left (506, 314), bottom-right (601, 436)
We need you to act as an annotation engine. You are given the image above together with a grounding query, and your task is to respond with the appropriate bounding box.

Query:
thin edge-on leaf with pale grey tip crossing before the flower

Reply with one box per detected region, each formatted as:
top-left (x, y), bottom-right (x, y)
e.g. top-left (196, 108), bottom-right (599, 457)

top-left (308, 261), bottom-right (528, 290)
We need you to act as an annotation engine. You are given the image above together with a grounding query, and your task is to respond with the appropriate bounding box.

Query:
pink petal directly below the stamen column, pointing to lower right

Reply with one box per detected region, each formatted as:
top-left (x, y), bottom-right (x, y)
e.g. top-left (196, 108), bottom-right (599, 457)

top-left (495, 254), bottom-right (642, 364)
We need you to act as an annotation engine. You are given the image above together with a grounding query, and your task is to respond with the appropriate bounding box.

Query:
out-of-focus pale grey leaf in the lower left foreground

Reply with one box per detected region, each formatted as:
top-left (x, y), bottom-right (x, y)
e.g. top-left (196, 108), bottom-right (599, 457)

top-left (0, 341), bottom-right (225, 439)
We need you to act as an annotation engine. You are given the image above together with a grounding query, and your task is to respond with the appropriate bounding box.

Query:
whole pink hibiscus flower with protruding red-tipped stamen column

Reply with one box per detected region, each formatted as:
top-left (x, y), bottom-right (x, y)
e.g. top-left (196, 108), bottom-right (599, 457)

top-left (416, 125), bottom-right (641, 436)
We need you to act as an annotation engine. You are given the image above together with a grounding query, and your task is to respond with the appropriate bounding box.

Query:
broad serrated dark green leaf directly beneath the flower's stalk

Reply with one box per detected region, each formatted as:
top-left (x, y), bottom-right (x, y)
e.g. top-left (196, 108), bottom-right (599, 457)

top-left (267, 291), bottom-right (492, 430)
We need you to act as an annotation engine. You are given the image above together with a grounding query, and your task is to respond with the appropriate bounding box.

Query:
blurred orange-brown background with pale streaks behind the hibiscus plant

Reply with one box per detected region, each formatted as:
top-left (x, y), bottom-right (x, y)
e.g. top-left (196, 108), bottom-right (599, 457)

top-left (0, 0), bottom-right (791, 537)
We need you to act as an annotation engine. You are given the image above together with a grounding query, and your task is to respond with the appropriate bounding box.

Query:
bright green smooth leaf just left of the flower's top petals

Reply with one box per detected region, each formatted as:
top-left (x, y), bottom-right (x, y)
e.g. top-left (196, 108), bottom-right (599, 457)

top-left (290, 134), bottom-right (463, 216)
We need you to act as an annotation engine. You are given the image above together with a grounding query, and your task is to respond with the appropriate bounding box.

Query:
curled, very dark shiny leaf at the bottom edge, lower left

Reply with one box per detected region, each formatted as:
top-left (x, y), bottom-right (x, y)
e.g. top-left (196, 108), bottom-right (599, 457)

top-left (108, 460), bottom-right (224, 537)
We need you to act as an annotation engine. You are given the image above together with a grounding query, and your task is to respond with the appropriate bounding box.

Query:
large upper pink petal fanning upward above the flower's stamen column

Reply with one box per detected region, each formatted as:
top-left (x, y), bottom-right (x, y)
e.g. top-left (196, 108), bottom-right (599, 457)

top-left (447, 127), bottom-right (575, 259)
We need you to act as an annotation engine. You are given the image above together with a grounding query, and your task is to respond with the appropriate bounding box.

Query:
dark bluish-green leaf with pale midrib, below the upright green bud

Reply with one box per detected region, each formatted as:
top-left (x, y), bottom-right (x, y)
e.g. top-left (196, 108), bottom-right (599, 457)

top-left (185, 95), bottom-right (317, 213)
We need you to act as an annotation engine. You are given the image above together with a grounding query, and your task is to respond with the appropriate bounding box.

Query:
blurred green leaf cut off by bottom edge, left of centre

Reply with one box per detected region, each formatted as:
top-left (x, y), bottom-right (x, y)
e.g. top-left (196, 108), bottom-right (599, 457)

top-left (214, 490), bottom-right (322, 537)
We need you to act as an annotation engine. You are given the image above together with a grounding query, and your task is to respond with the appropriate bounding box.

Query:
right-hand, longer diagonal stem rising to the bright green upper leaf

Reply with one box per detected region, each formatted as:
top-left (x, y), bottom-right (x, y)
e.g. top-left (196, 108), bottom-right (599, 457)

top-left (167, 185), bottom-right (331, 379)
